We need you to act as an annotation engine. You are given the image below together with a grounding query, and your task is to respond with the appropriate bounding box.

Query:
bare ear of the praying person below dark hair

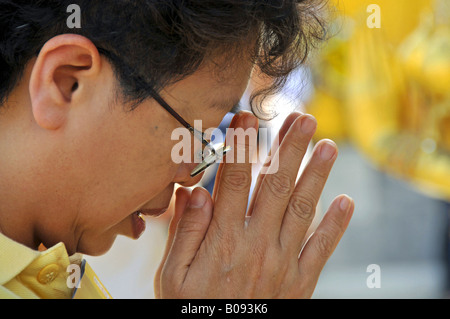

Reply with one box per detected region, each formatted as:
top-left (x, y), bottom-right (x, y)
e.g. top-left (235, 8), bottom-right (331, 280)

top-left (29, 34), bottom-right (101, 130)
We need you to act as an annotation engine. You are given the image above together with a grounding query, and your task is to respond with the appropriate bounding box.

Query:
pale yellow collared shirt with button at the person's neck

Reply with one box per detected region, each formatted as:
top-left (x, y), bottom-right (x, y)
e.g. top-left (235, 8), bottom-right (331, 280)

top-left (0, 234), bottom-right (110, 299)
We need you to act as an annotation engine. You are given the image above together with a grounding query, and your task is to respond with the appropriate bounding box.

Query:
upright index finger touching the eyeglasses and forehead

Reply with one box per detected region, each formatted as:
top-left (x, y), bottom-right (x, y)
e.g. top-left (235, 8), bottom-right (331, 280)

top-left (213, 112), bottom-right (258, 228)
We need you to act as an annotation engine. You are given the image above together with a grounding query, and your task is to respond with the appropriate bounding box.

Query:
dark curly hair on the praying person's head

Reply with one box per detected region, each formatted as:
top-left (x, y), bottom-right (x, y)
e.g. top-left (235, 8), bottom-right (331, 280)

top-left (0, 0), bottom-right (325, 117)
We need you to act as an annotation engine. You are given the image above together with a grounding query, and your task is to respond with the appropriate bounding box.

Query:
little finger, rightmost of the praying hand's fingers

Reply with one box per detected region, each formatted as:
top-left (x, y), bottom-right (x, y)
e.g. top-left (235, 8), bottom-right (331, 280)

top-left (299, 195), bottom-right (355, 293)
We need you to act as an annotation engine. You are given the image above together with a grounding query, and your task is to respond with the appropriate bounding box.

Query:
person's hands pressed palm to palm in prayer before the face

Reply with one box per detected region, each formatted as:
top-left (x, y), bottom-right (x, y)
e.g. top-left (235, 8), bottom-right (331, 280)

top-left (155, 112), bottom-right (354, 299)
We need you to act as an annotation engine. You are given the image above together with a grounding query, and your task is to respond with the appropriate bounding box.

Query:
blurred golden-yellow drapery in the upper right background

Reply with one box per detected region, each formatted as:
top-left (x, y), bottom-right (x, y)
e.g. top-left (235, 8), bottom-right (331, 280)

top-left (306, 0), bottom-right (450, 201)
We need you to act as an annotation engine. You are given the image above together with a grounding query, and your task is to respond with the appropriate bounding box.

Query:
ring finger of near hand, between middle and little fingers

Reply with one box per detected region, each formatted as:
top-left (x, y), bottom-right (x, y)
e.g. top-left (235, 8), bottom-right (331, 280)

top-left (280, 140), bottom-right (338, 257)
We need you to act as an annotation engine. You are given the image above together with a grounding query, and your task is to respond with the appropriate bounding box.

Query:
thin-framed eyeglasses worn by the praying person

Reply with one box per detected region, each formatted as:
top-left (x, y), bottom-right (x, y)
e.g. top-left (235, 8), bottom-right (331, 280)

top-left (150, 90), bottom-right (231, 177)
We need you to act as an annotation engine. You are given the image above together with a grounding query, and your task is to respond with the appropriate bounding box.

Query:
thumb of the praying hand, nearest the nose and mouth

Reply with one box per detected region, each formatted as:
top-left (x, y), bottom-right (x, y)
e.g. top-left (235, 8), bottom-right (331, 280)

top-left (164, 188), bottom-right (213, 284)
